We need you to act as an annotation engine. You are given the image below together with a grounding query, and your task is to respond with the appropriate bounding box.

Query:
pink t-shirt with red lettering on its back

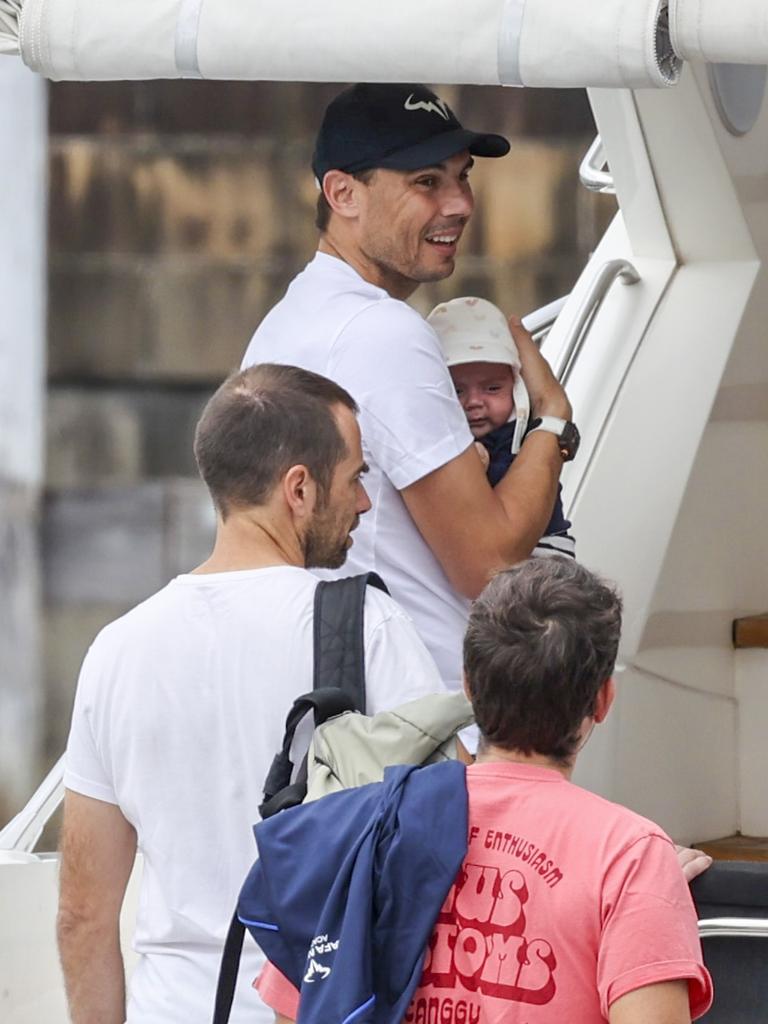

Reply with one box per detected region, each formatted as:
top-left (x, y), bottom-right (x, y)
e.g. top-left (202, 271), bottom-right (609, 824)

top-left (256, 762), bottom-right (712, 1024)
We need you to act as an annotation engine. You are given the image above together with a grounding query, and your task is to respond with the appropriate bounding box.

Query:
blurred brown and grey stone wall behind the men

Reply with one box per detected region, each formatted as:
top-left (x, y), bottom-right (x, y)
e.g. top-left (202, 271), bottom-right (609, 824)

top-left (1, 82), bottom-right (614, 827)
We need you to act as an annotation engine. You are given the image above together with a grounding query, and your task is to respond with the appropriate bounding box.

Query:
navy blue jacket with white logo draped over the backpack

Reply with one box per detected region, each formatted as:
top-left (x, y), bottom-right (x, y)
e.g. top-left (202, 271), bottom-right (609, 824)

top-left (238, 761), bottom-right (467, 1024)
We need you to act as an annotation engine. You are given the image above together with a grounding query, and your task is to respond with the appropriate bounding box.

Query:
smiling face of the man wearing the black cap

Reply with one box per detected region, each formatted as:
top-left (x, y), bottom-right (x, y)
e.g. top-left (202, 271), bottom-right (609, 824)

top-left (356, 151), bottom-right (474, 297)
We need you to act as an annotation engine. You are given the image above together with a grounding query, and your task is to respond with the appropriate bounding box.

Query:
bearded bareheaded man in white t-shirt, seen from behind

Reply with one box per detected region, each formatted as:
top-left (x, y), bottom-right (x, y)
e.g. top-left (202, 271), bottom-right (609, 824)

top-left (58, 365), bottom-right (442, 1024)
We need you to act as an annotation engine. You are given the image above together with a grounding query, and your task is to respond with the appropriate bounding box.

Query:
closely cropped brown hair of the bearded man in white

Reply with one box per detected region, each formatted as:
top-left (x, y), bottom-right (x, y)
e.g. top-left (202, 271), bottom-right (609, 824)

top-left (195, 362), bottom-right (357, 519)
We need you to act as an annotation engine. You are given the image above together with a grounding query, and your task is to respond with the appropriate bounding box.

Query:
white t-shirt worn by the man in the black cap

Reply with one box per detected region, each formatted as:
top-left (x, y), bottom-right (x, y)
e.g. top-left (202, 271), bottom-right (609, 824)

top-left (243, 253), bottom-right (472, 689)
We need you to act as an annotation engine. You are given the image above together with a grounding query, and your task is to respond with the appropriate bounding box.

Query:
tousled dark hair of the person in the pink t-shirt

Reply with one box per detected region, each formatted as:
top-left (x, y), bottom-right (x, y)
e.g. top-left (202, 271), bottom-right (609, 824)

top-left (464, 556), bottom-right (622, 764)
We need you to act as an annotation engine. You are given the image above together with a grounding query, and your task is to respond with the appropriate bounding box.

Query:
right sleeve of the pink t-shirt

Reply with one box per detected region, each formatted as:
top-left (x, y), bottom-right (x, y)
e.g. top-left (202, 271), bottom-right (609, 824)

top-left (597, 835), bottom-right (712, 1019)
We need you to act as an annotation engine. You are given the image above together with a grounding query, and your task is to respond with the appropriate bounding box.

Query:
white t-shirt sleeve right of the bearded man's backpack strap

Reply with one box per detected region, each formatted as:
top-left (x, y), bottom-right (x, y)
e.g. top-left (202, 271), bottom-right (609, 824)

top-left (365, 587), bottom-right (445, 715)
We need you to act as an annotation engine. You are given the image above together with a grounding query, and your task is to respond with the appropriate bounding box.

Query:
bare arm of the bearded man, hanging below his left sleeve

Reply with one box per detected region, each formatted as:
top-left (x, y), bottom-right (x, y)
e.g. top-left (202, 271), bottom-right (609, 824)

top-left (56, 790), bottom-right (136, 1024)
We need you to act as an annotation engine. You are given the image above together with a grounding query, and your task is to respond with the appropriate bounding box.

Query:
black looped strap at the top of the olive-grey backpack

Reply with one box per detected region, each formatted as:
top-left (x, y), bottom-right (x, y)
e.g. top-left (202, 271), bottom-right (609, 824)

top-left (259, 686), bottom-right (355, 818)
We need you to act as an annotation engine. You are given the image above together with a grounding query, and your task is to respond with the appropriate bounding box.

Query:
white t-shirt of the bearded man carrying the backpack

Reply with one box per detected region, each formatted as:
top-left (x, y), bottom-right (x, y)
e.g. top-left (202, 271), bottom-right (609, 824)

top-left (65, 566), bottom-right (442, 1024)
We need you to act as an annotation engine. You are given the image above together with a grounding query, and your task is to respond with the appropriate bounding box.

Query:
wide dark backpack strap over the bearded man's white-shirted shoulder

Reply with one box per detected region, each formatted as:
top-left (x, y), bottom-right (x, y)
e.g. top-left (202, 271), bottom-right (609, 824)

top-left (312, 572), bottom-right (389, 715)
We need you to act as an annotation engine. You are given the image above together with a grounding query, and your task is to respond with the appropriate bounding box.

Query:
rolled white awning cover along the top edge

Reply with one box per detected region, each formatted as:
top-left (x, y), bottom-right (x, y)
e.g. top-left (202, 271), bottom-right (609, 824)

top-left (0, 0), bottom-right (768, 88)
